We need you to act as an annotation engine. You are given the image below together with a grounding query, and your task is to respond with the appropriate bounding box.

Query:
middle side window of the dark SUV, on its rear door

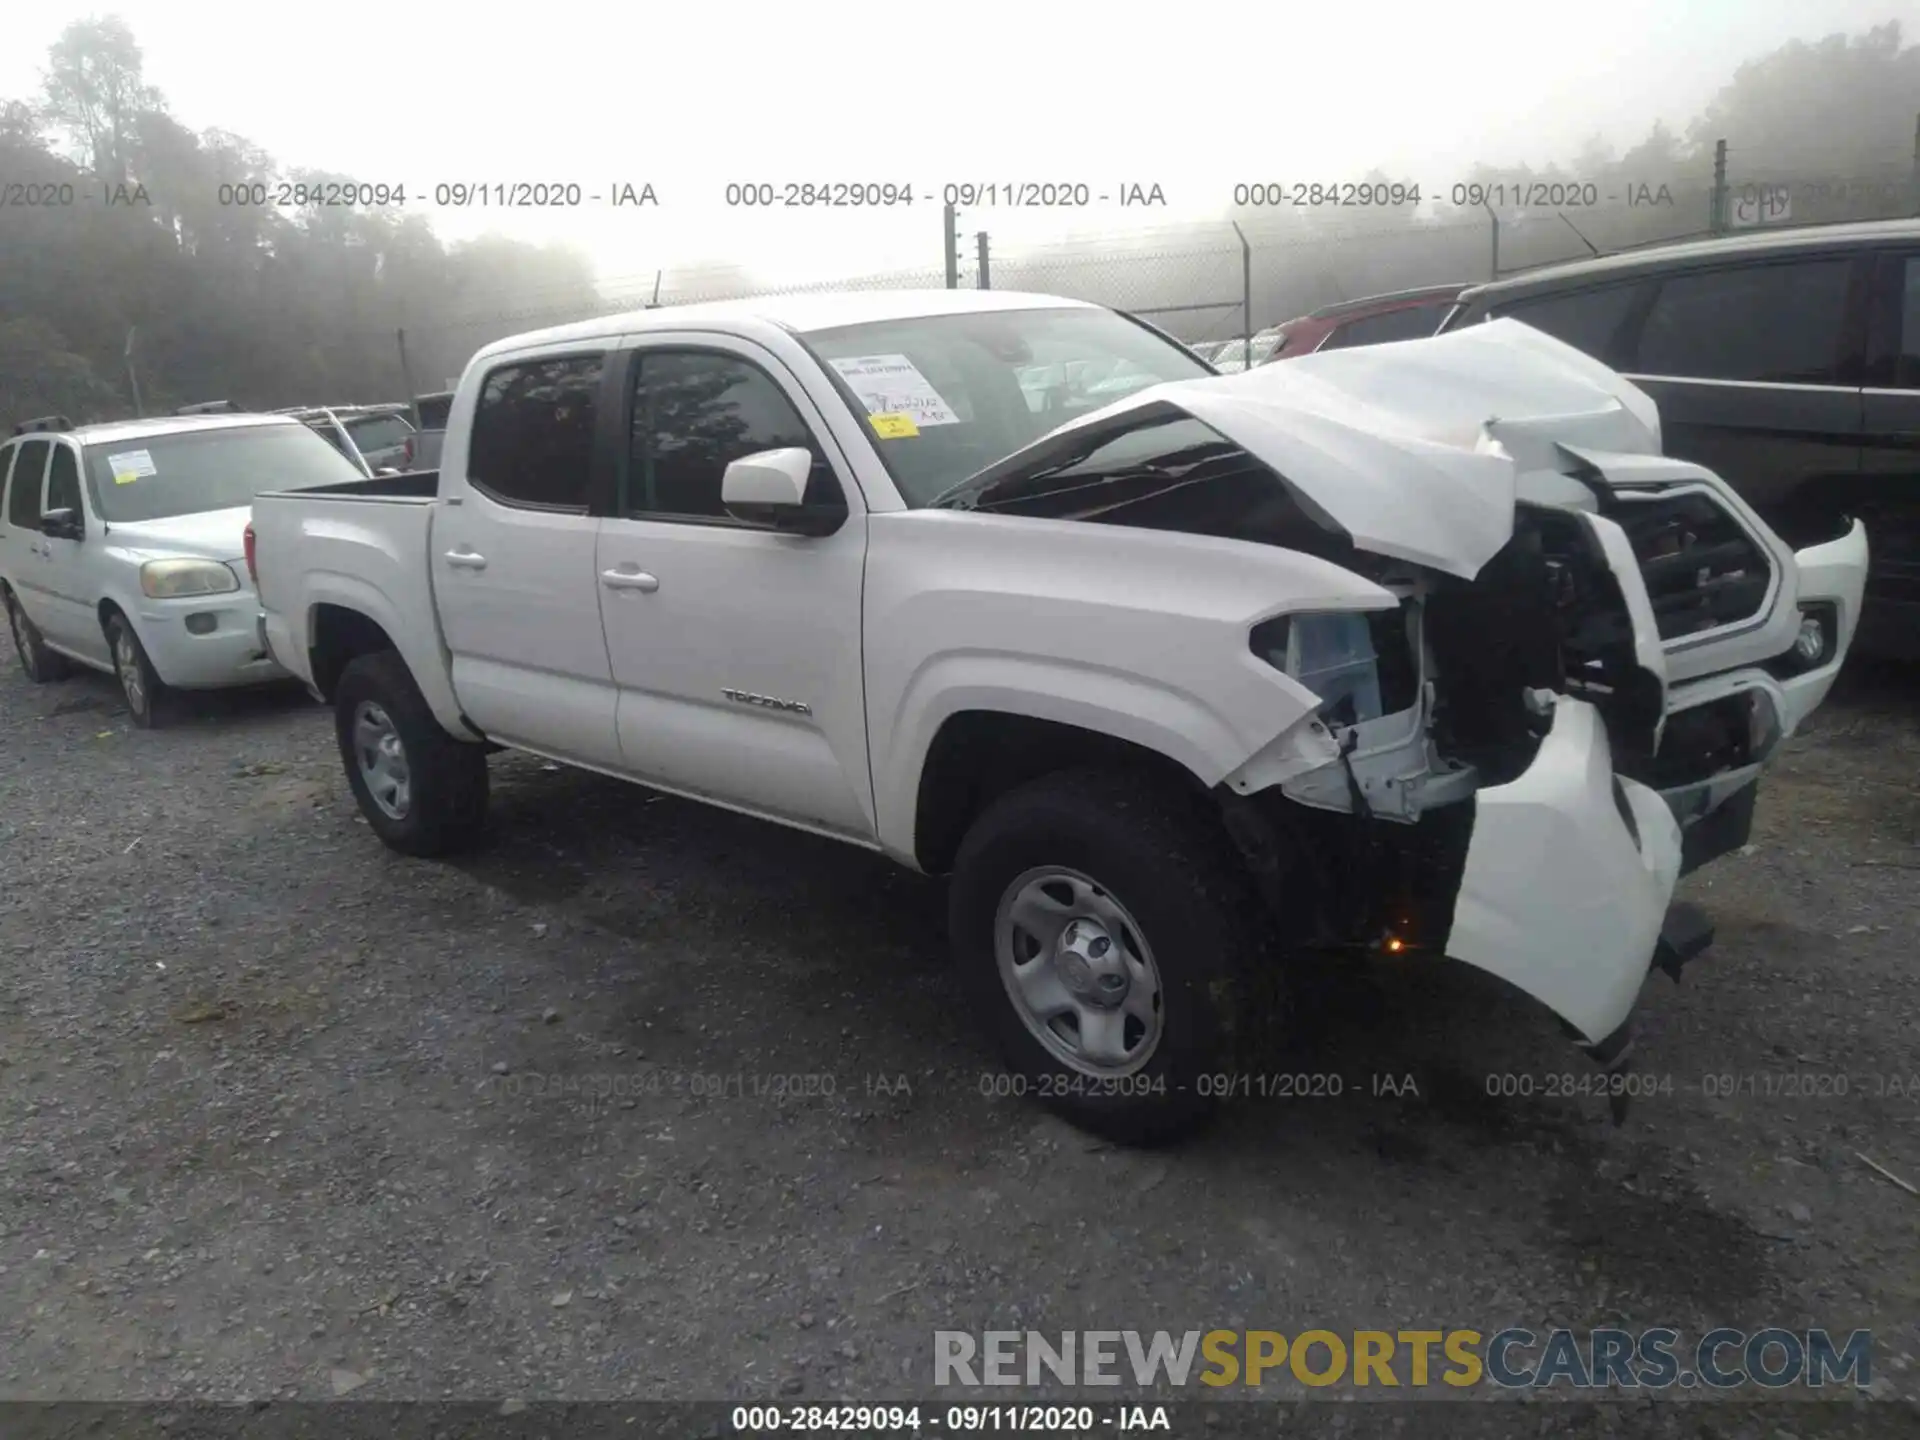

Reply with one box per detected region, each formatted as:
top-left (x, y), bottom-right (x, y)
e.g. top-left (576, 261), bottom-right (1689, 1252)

top-left (1628, 259), bottom-right (1853, 384)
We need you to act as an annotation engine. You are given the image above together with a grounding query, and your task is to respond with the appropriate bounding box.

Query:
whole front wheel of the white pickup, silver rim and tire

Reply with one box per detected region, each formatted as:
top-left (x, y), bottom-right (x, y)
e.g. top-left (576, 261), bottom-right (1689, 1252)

top-left (948, 770), bottom-right (1267, 1144)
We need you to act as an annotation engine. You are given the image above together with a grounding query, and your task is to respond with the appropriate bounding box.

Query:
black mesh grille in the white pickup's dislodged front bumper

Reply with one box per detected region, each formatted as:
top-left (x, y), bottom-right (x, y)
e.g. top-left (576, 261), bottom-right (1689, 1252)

top-left (1615, 492), bottom-right (1772, 639)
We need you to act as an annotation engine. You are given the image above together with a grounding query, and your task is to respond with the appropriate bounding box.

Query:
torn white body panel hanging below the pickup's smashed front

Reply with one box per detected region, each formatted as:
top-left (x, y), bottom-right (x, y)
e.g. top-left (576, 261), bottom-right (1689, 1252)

top-left (1446, 697), bottom-right (1680, 1043)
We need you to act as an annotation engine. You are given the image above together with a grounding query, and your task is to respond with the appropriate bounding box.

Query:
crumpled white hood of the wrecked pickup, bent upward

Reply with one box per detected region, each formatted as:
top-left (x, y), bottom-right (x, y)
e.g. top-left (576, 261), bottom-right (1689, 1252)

top-left (1056, 321), bottom-right (1661, 580)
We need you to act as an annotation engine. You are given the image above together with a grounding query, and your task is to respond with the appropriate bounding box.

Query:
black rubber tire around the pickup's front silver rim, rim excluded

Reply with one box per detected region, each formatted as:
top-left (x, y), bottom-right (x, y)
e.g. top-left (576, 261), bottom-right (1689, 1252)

top-left (948, 770), bottom-right (1277, 1144)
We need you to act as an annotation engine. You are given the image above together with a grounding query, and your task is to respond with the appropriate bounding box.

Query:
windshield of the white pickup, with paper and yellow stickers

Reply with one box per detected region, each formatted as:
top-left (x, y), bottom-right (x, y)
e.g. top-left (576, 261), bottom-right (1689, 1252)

top-left (806, 307), bottom-right (1210, 507)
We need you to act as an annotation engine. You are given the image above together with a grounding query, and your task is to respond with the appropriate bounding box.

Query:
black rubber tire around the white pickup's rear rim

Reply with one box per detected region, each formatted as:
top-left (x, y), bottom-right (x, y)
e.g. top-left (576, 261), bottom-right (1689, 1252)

top-left (334, 651), bottom-right (488, 856)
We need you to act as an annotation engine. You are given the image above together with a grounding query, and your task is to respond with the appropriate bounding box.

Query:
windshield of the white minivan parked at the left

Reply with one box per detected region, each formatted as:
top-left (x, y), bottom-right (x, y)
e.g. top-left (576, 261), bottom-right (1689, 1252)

top-left (86, 424), bottom-right (363, 524)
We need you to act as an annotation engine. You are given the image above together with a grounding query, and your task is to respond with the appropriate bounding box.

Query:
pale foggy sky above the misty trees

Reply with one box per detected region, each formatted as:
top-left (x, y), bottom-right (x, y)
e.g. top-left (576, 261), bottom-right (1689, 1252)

top-left (0, 0), bottom-right (1920, 282)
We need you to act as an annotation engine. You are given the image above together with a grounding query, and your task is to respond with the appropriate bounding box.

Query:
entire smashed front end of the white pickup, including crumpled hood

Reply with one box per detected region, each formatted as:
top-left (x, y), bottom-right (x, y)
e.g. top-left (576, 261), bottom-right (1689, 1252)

top-left (941, 321), bottom-right (1866, 1066)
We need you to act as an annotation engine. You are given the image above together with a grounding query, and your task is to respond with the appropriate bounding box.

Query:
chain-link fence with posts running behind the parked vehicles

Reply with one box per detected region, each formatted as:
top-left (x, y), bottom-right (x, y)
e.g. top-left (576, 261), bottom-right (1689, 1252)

top-left (393, 136), bottom-right (1920, 384)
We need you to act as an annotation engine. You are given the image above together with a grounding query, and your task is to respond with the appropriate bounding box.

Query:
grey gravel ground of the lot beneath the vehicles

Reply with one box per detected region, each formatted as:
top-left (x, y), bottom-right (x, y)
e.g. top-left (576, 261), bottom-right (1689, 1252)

top-left (0, 664), bottom-right (1920, 1434)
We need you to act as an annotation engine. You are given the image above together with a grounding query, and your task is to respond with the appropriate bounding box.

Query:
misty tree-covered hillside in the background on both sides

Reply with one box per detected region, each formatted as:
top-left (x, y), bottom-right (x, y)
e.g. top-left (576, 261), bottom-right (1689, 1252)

top-left (0, 17), bottom-right (1920, 419)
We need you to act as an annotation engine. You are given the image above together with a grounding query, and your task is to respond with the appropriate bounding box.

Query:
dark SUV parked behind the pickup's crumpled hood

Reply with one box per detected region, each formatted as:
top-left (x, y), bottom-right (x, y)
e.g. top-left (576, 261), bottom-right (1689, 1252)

top-left (1440, 219), bottom-right (1920, 659)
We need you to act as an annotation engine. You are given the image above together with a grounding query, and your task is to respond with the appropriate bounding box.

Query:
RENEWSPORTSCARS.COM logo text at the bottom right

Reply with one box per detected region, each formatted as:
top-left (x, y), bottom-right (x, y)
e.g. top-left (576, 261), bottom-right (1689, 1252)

top-left (933, 1325), bottom-right (1874, 1390)
